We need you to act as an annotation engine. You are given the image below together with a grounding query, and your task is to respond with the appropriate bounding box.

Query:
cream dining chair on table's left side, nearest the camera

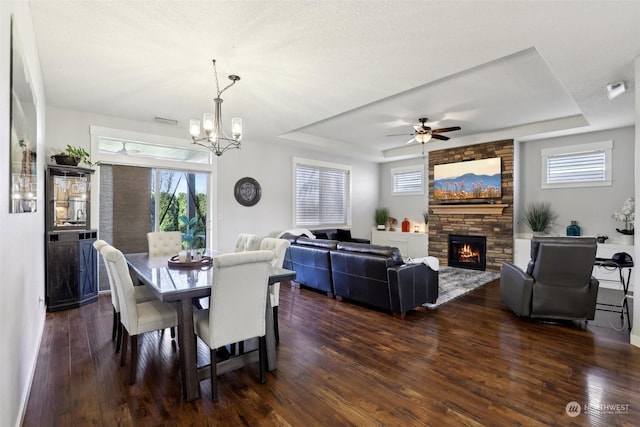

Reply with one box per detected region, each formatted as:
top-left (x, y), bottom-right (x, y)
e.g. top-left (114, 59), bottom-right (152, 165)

top-left (101, 246), bottom-right (178, 384)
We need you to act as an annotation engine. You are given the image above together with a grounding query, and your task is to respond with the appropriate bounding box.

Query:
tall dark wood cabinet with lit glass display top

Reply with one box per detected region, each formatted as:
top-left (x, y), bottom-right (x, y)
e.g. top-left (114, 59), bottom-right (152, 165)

top-left (45, 166), bottom-right (98, 311)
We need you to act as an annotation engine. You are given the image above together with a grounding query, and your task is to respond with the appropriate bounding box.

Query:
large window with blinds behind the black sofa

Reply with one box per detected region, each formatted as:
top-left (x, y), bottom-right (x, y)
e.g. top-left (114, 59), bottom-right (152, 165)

top-left (293, 158), bottom-right (351, 227)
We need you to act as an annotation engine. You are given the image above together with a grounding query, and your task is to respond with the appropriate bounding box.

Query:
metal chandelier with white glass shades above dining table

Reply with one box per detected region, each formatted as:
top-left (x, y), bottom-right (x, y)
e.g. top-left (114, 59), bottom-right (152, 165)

top-left (189, 59), bottom-right (242, 156)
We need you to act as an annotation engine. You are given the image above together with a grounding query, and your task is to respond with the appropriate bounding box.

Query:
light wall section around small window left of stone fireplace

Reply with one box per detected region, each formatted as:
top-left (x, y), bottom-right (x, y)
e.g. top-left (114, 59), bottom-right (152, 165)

top-left (378, 154), bottom-right (429, 231)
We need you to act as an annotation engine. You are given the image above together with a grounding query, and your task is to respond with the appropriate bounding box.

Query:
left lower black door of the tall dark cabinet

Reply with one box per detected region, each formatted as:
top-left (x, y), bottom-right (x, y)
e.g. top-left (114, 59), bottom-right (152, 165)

top-left (47, 241), bottom-right (78, 310)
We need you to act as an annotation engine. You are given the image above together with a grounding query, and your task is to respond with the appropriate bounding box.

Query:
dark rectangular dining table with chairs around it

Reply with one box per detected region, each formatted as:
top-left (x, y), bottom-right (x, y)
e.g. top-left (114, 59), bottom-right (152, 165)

top-left (125, 252), bottom-right (296, 401)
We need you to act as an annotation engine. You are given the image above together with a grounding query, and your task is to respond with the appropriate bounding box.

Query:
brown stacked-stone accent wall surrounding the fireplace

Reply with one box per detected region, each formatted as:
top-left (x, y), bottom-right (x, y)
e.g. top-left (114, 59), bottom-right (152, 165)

top-left (429, 139), bottom-right (513, 271)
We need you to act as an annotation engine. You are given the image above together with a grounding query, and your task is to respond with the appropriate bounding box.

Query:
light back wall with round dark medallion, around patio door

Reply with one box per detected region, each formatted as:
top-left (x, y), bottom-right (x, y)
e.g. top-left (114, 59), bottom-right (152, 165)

top-left (47, 108), bottom-right (378, 251)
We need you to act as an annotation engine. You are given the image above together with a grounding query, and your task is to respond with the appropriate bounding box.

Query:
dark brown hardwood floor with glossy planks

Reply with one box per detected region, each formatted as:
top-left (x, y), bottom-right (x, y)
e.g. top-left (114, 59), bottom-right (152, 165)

top-left (24, 282), bottom-right (640, 426)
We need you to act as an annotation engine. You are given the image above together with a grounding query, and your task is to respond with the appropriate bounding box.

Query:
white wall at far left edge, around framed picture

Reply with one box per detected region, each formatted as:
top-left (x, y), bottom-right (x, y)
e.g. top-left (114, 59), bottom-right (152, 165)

top-left (0, 1), bottom-right (46, 426)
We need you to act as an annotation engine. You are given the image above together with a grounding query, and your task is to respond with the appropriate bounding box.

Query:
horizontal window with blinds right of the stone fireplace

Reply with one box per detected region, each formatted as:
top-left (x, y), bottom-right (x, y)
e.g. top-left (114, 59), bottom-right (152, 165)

top-left (542, 141), bottom-right (613, 188)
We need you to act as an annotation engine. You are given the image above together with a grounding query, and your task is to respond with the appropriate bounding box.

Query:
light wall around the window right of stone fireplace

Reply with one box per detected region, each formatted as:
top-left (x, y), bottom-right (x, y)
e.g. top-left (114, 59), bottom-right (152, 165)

top-left (514, 127), bottom-right (635, 243)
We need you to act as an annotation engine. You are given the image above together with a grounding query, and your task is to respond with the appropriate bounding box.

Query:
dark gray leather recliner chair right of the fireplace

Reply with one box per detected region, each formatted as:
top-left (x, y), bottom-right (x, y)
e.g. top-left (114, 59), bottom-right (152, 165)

top-left (500, 237), bottom-right (599, 320)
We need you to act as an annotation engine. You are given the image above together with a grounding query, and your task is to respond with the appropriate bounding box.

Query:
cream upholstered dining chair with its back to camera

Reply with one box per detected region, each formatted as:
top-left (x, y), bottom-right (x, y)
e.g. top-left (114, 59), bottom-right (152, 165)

top-left (193, 250), bottom-right (273, 402)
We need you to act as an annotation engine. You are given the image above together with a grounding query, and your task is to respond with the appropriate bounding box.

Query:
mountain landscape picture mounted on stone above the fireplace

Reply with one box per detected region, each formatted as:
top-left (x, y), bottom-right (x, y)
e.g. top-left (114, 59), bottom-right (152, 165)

top-left (433, 157), bottom-right (502, 201)
